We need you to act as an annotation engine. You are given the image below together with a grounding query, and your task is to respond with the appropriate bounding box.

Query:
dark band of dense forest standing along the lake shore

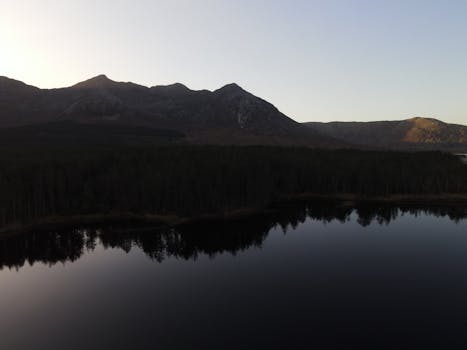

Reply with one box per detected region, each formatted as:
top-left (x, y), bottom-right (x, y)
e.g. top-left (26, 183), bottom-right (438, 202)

top-left (0, 146), bottom-right (467, 226)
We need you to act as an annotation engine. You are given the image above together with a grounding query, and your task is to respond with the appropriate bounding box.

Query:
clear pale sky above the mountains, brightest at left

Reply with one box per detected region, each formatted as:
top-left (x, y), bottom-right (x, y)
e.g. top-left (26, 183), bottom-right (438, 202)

top-left (0, 0), bottom-right (467, 124)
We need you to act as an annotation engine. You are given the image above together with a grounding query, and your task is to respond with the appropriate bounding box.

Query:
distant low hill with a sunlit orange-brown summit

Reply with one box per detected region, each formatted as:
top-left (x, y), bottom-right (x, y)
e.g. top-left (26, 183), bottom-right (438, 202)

top-left (305, 117), bottom-right (467, 152)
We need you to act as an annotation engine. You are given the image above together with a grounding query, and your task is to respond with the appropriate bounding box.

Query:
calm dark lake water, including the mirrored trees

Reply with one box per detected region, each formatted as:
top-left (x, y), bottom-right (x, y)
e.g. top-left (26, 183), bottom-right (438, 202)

top-left (0, 203), bottom-right (467, 350)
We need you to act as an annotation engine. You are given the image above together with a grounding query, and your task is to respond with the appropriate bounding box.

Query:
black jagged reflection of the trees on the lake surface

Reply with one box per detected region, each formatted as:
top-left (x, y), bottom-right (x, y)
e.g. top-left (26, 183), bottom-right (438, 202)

top-left (0, 202), bottom-right (467, 269)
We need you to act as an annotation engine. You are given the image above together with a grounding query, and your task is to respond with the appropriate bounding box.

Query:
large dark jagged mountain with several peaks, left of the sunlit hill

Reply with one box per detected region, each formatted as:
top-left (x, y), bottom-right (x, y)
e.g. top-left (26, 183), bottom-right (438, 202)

top-left (0, 75), bottom-right (345, 147)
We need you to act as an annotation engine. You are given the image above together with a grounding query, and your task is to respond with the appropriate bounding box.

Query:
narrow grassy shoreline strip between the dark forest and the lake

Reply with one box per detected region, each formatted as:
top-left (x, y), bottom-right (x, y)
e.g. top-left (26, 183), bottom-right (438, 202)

top-left (0, 193), bottom-right (467, 236)
